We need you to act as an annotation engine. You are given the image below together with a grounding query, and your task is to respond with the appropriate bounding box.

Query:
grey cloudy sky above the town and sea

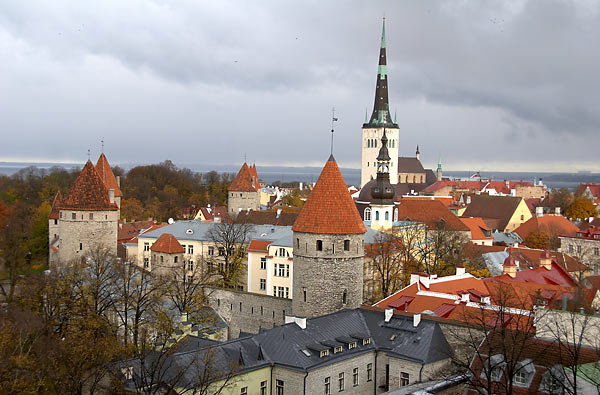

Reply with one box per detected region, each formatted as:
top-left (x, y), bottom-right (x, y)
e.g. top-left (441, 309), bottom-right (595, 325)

top-left (0, 0), bottom-right (600, 171)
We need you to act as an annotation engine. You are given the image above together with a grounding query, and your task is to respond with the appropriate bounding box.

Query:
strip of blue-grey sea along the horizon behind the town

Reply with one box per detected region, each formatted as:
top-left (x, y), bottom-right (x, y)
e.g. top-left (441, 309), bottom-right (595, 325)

top-left (0, 162), bottom-right (600, 190)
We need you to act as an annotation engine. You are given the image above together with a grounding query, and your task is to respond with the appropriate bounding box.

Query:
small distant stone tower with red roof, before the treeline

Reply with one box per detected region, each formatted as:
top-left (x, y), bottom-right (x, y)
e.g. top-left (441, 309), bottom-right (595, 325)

top-left (227, 162), bottom-right (260, 217)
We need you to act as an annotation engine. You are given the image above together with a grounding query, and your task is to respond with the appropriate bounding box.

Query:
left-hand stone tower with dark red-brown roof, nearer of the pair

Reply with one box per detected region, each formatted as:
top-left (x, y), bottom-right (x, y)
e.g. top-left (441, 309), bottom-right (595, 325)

top-left (57, 160), bottom-right (119, 265)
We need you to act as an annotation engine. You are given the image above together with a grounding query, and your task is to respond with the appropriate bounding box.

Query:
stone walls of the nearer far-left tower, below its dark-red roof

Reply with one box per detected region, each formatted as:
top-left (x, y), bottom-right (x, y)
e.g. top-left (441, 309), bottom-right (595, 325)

top-left (58, 210), bottom-right (119, 264)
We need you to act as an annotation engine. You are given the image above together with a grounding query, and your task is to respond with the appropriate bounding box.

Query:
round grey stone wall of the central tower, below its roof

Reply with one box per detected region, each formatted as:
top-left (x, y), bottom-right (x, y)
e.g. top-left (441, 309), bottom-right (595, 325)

top-left (292, 232), bottom-right (364, 318)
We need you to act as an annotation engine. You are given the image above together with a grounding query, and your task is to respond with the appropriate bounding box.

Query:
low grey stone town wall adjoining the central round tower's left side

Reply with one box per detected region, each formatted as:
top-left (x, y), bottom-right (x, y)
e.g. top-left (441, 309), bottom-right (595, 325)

top-left (206, 288), bottom-right (292, 339)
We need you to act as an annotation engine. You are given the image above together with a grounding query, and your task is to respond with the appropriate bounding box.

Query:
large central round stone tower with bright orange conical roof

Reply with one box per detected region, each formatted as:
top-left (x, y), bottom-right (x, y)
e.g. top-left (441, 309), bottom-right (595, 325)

top-left (292, 155), bottom-right (366, 317)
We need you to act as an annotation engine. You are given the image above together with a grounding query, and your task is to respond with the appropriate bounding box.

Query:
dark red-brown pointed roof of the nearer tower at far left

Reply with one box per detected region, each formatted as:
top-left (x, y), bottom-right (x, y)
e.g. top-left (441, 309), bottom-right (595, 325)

top-left (59, 160), bottom-right (118, 211)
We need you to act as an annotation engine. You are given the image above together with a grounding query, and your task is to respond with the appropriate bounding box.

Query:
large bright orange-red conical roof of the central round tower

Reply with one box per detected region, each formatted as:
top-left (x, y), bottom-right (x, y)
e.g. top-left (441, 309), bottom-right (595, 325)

top-left (292, 155), bottom-right (367, 234)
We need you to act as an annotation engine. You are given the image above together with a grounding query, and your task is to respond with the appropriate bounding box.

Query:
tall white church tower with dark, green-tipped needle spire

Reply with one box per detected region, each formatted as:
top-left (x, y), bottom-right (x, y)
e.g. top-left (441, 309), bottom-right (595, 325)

top-left (360, 18), bottom-right (400, 188)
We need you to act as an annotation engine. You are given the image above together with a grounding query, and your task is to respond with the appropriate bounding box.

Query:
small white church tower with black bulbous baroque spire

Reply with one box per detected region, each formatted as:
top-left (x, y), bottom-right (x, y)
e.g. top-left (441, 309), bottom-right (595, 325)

top-left (369, 130), bottom-right (396, 229)
